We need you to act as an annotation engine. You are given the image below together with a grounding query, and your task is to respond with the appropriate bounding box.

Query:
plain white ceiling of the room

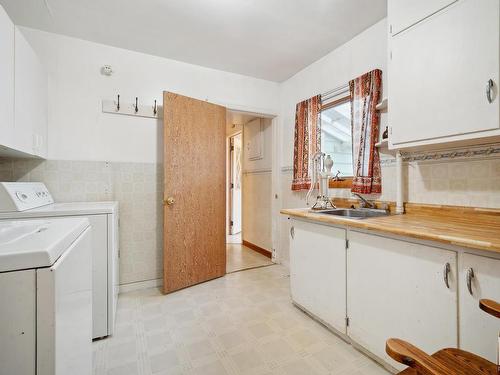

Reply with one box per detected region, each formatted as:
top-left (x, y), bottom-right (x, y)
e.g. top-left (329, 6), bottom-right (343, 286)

top-left (0, 0), bottom-right (386, 82)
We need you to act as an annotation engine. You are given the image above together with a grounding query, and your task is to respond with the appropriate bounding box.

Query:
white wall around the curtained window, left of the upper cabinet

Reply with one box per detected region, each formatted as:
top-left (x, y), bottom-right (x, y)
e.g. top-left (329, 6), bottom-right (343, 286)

top-left (276, 19), bottom-right (387, 265)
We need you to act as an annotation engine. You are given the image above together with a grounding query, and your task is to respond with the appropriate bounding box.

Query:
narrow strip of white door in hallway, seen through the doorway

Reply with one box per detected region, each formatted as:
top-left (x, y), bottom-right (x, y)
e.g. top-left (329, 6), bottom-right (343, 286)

top-left (231, 133), bottom-right (242, 234)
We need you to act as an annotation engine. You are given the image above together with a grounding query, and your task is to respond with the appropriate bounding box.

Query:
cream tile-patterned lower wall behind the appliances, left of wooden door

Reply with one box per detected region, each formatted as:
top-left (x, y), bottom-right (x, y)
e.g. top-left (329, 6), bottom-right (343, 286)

top-left (0, 158), bottom-right (163, 284)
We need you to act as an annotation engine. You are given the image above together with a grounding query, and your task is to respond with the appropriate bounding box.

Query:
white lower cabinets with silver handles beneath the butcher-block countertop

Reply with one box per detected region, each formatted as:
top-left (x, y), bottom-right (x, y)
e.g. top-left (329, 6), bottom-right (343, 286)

top-left (290, 219), bottom-right (500, 369)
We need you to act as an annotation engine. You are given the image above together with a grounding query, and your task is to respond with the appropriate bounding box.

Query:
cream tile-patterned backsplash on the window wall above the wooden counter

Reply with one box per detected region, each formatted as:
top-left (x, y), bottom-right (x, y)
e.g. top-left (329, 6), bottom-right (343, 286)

top-left (279, 154), bottom-right (500, 265)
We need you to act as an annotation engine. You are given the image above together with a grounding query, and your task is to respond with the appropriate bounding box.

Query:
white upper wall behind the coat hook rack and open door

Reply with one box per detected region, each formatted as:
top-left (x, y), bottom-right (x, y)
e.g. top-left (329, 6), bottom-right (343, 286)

top-left (22, 28), bottom-right (279, 163)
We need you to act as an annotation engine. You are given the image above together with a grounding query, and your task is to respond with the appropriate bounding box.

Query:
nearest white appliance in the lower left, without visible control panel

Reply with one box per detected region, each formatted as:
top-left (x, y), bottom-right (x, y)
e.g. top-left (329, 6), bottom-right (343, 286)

top-left (0, 219), bottom-right (92, 375)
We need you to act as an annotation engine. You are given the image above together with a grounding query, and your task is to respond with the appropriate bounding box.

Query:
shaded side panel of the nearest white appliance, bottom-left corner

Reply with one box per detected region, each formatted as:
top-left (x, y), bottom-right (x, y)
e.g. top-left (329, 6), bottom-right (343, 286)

top-left (0, 270), bottom-right (36, 375)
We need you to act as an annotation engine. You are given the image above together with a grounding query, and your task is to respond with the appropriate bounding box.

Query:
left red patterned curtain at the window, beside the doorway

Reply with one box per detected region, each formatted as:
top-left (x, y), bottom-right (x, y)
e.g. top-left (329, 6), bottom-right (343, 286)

top-left (292, 95), bottom-right (321, 191)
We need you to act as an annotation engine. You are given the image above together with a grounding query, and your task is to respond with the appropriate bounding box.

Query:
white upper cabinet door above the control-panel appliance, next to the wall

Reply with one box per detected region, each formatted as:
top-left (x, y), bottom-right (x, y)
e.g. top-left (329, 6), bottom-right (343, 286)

top-left (15, 28), bottom-right (48, 157)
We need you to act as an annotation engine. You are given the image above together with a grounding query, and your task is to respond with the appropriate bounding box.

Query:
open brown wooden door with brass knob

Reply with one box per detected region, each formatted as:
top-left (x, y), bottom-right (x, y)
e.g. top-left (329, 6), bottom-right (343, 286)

top-left (163, 92), bottom-right (226, 293)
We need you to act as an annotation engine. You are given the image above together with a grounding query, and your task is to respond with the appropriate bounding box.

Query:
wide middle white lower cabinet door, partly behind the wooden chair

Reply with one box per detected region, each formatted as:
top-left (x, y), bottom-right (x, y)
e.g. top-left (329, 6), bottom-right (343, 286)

top-left (347, 231), bottom-right (458, 368)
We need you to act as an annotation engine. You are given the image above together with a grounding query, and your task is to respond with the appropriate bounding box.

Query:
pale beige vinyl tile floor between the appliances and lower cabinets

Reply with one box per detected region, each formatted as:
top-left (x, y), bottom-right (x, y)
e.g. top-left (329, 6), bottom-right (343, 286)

top-left (93, 265), bottom-right (387, 375)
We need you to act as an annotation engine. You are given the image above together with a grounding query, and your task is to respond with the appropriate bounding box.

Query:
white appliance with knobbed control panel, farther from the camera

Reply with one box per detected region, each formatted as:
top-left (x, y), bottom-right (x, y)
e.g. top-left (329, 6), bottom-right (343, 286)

top-left (0, 182), bottom-right (119, 338)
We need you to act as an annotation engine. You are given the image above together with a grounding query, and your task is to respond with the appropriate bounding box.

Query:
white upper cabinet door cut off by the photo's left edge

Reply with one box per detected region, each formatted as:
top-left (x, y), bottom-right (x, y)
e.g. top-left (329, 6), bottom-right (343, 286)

top-left (0, 5), bottom-right (14, 147)
